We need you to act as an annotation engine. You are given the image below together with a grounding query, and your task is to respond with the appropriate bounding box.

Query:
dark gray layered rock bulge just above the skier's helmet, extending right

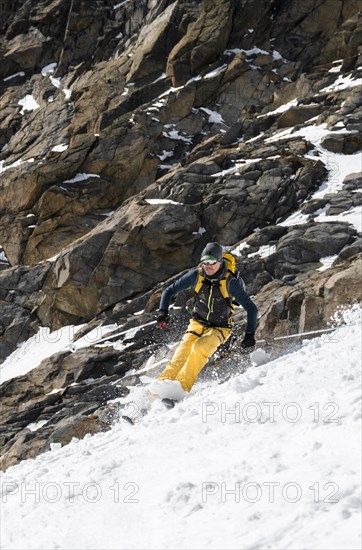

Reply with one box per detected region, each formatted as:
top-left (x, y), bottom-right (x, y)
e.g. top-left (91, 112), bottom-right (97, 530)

top-left (202, 155), bottom-right (326, 243)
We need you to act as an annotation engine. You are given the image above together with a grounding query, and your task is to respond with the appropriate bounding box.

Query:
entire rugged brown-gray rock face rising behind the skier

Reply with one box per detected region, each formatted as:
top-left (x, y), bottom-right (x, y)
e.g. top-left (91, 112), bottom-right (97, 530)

top-left (0, 0), bottom-right (362, 469)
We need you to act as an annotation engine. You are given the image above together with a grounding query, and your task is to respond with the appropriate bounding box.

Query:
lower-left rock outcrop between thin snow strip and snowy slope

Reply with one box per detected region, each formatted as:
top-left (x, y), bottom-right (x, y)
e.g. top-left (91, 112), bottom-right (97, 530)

top-left (0, 350), bottom-right (129, 469)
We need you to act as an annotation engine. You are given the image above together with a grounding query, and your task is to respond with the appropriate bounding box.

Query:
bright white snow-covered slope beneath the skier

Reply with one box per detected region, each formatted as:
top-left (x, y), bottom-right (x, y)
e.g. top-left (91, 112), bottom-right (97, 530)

top-left (1, 309), bottom-right (361, 550)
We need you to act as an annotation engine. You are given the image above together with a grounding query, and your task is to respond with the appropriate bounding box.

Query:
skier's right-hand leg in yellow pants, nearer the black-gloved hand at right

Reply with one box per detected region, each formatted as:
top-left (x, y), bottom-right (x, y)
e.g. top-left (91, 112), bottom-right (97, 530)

top-left (176, 328), bottom-right (231, 391)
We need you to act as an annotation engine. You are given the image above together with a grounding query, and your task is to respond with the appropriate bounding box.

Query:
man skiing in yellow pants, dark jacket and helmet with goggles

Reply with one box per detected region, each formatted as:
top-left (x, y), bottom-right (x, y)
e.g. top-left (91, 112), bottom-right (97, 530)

top-left (150, 242), bottom-right (258, 400)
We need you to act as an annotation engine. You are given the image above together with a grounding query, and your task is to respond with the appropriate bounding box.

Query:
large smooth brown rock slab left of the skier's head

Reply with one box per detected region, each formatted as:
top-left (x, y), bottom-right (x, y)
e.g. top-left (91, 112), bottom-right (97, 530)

top-left (38, 200), bottom-right (199, 327)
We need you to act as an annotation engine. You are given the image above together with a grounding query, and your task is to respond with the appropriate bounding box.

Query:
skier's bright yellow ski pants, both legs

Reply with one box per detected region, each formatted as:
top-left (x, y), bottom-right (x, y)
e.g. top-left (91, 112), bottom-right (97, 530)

top-left (158, 319), bottom-right (231, 391)
